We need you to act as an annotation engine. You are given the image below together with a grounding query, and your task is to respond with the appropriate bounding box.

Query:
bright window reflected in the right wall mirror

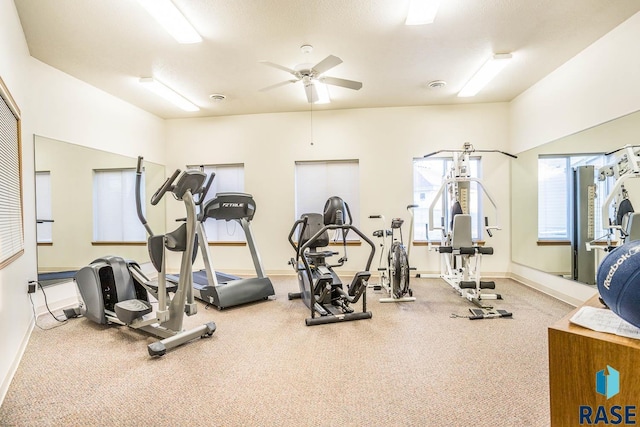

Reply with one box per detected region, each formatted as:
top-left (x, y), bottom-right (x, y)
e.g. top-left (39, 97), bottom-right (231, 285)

top-left (538, 154), bottom-right (608, 240)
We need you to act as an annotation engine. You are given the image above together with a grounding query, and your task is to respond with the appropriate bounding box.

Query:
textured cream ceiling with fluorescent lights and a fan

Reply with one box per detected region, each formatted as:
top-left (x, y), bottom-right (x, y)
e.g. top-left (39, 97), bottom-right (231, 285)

top-left (15, 0), bottom-right (640, 118)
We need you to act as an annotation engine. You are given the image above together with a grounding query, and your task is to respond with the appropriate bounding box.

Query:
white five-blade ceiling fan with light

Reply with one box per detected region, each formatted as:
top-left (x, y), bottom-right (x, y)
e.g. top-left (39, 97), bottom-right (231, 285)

top-left (260, 55), bottom-right (362, 103)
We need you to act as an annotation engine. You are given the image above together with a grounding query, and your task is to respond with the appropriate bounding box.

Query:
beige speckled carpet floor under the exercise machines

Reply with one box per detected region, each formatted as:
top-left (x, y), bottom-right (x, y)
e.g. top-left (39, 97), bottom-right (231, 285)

top-left (0, 276), bottom-right (572, 427)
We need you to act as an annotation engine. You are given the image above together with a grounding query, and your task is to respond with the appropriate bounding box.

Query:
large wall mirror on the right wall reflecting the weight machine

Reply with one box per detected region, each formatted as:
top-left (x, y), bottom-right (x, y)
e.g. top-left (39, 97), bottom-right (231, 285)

top-left (511, 112), bottom-right (640, 284)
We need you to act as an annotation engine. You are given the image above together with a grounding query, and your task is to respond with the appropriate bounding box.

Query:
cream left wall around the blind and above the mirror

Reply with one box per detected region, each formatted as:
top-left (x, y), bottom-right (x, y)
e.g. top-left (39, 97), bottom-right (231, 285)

top-left (0, 0), bottom-right (165, 402)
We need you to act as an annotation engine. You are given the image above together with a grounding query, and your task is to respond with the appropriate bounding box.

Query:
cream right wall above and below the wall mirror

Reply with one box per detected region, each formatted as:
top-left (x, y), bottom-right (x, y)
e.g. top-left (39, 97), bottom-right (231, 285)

top-left (509, 13), bottom-right (640, 302)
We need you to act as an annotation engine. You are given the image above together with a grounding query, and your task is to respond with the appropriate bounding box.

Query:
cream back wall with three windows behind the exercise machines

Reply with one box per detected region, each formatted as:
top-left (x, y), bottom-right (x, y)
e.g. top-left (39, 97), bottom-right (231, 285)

top-left (167, 103), bottom-right (510, 273)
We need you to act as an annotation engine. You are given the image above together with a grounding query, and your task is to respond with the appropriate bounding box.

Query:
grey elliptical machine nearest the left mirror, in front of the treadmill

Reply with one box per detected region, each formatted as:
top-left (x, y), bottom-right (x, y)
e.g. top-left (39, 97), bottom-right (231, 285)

top-left (74, 157), bottom-right (216, 356)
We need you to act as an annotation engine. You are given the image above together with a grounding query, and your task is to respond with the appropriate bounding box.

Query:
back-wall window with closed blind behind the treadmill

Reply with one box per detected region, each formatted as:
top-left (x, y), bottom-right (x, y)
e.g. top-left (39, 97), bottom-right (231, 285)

top-left (195, 164), bottom-right (245, 242)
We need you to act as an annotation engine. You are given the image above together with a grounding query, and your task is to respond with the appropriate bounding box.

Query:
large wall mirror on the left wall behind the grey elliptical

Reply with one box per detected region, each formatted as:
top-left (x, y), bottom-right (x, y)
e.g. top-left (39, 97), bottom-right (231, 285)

top-left (34, 135), bottom-right (166, 285)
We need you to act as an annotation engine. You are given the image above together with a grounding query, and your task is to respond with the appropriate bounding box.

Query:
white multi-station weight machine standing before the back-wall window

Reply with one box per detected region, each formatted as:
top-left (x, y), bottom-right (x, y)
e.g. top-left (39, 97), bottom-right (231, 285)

top-left (424, 142), bottom-right (517, 319)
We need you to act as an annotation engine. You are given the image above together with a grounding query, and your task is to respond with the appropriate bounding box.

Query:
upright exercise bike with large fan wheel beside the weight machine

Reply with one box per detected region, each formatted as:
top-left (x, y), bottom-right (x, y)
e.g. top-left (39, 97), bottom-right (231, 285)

top-left (369, 205), bottom-right (417, 302)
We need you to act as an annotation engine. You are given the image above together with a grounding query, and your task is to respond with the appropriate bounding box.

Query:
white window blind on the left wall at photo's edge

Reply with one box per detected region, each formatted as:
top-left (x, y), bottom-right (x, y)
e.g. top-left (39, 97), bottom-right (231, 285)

top-left (0, 79), bottom-right (24, 267)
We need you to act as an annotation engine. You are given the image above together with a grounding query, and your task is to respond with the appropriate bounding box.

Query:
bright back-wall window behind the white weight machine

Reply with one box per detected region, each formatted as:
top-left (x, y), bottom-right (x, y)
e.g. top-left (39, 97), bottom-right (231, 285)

top-left (413, 157), bottom-right (484, 242)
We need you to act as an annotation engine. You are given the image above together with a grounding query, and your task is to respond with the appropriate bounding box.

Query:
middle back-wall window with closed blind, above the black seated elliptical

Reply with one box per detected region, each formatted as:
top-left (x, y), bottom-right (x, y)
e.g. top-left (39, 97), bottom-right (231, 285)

top-left (295, 160), bottom-right (360, 240)
